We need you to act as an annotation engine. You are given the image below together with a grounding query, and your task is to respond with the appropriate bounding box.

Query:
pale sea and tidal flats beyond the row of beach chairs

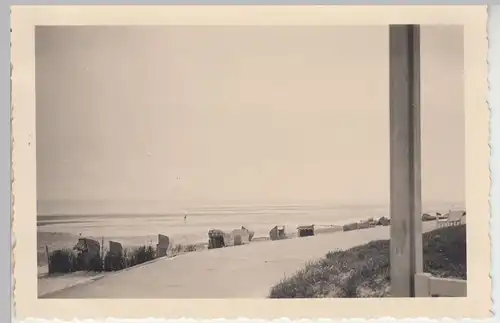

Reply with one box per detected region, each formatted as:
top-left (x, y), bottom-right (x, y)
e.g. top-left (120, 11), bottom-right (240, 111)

top-left (37, 203), bottom-right (460, 262)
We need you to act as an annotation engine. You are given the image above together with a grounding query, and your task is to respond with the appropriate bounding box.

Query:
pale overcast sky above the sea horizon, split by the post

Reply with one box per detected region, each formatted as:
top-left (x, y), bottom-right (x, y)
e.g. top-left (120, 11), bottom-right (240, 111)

top-left (36, 26), bottom-right (465, 213)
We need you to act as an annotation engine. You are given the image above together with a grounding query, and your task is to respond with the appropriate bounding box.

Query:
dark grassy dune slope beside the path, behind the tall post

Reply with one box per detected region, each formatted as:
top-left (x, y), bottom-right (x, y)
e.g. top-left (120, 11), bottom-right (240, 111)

top-left (269, 225), bottom-right (467, 298)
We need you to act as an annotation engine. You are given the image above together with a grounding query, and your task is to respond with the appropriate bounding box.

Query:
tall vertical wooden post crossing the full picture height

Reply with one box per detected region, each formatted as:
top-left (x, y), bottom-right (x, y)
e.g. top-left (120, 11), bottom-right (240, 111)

top-left (389, 25), bottom-right (423, 297)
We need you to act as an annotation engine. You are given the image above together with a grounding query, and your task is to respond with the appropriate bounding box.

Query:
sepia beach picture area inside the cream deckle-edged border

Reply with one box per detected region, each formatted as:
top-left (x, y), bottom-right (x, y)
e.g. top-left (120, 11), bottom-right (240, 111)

top-left (35, 25), bottom-right (467, 299)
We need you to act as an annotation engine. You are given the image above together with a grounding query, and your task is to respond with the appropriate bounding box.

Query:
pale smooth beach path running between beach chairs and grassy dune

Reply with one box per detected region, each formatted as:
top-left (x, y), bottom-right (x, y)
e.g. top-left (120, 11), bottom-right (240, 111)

top-left (43, 221), bottom-right (435, 298)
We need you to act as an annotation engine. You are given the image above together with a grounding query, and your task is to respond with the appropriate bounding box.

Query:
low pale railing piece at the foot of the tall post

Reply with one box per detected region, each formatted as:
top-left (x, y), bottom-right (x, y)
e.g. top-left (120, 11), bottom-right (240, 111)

top-left (415, 273), bottom-right (467, 297)
